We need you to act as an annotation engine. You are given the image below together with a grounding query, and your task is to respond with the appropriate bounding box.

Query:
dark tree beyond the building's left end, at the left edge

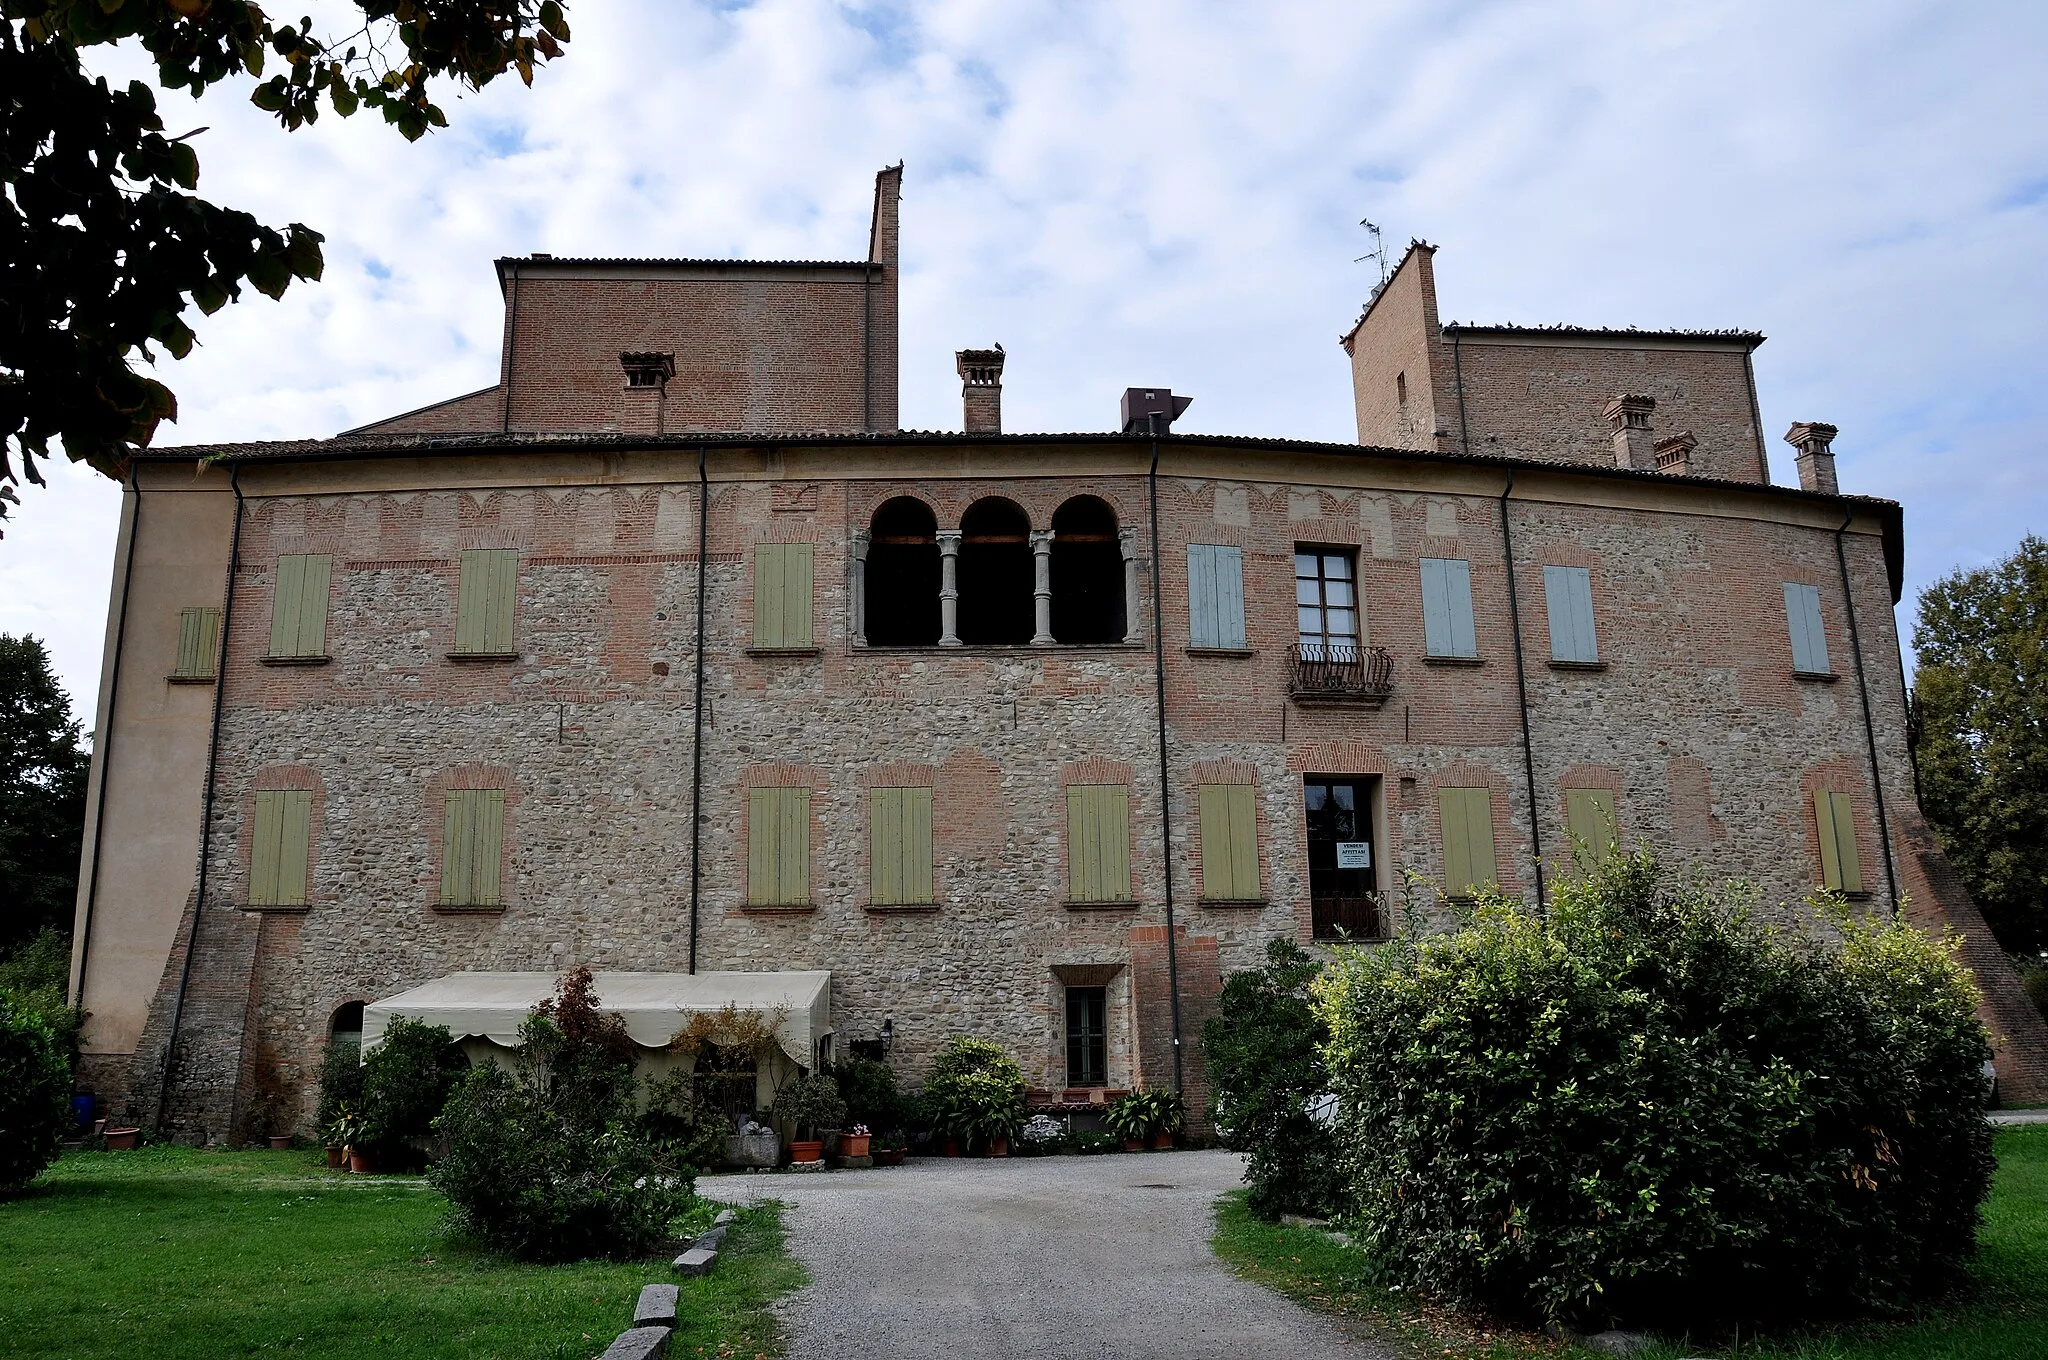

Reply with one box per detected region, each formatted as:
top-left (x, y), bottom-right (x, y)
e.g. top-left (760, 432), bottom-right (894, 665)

top-left (0, 633), bottom-right (92, 954)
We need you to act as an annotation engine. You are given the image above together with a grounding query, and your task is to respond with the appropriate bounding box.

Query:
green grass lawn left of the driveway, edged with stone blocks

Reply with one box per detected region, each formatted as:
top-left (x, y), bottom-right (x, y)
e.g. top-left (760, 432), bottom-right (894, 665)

top-left (0, 1147), bottom-right (803, 1360)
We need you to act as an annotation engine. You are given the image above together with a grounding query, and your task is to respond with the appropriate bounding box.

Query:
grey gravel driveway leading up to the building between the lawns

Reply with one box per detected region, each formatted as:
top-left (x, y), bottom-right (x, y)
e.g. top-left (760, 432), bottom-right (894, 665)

top-left (698, 1151), bottom-right (1389, 1360)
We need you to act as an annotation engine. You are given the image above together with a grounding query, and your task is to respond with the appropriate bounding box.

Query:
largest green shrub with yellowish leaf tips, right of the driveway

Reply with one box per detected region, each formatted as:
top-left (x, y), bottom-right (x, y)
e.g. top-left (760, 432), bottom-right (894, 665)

top-left (1315, 856), bottom-right (1991, 1325)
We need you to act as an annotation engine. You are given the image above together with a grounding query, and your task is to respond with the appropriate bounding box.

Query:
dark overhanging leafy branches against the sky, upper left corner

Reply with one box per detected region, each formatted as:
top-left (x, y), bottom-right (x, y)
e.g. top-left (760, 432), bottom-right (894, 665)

top-left (0, 0), bottom-right (569, 514)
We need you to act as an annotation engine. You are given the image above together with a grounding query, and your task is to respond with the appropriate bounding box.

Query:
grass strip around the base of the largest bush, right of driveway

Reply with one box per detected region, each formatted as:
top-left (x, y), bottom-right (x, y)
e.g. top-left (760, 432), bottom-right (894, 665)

top-left (1214, 1124), bottom-right (2048, 1360)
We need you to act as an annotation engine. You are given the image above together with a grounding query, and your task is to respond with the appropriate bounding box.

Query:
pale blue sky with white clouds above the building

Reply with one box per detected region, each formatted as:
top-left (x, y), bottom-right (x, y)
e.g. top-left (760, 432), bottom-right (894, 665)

top-left (0, 0), bottom-right (2048, 723)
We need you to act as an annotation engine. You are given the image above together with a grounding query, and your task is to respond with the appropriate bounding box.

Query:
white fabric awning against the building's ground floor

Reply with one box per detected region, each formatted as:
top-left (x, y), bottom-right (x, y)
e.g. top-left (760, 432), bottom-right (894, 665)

top-left (362, 973), bottom-right (831, 1067)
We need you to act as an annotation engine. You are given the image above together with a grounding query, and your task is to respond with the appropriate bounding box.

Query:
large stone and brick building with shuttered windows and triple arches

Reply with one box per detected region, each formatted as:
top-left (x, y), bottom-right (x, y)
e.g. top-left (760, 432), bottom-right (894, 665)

top-left (74, 170), bottom-right (2048, 1137)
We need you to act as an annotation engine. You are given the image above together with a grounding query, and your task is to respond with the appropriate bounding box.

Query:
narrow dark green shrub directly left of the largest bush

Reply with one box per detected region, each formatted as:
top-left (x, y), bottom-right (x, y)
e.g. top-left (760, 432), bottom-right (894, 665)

top-left (1202, 940), bottom-right (1341, 1219)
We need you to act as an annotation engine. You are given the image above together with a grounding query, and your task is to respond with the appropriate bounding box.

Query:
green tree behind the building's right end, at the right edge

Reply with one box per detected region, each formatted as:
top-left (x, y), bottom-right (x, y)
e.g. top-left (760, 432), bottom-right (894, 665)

top-left (1913, 535), bottom-right (2048, 950)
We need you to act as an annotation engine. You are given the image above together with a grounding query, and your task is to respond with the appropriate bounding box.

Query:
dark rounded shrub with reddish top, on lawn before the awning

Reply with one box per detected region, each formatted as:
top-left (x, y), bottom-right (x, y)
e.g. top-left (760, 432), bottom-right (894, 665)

top-left (428, 969), bottom-right (692, 1262)
